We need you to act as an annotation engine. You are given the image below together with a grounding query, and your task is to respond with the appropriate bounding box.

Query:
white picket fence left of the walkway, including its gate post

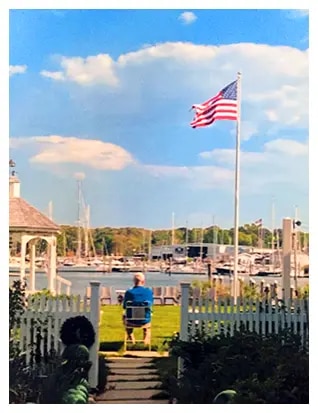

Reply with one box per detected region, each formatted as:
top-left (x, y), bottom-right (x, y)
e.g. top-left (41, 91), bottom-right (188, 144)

top-left (14, 281), bottom-right (100, 388)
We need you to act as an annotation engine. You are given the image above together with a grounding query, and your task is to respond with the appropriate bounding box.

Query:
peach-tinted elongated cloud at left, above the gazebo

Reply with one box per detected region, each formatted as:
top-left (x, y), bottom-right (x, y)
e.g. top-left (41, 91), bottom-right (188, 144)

top-left (10, 136), bottom-right (135, 170)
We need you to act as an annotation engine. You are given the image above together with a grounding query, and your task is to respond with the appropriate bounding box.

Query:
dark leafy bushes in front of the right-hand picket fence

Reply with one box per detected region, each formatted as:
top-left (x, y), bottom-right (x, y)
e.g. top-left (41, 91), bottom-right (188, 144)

top-left (168, 329), bottom-right (309, 404)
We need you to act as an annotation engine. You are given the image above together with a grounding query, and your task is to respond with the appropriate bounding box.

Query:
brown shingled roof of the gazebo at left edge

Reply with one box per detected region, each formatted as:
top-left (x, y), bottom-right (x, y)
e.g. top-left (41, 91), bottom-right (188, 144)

top-left (9, 197), bottom-right (60, 232)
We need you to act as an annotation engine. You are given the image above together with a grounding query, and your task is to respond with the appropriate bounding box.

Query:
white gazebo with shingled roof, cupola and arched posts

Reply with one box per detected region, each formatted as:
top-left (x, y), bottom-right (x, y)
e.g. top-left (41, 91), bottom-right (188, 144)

top-left (9, 161), bottom-right (60, 293)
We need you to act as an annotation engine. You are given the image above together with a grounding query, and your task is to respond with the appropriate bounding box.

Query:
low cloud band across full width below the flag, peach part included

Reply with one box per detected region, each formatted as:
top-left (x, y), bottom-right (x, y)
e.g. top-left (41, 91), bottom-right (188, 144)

top-left (10, 135), bottom-right (308, 194)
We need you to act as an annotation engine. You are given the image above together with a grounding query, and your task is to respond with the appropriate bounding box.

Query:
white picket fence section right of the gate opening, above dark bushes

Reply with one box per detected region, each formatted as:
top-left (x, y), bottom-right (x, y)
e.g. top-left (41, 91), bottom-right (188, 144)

top-left (180, 283), bottom-right (309, 343)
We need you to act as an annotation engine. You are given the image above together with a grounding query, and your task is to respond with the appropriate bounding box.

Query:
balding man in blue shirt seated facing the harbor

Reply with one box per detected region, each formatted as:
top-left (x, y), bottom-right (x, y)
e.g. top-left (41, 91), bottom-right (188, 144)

top-left (123, 272), bottom-right (153, 345)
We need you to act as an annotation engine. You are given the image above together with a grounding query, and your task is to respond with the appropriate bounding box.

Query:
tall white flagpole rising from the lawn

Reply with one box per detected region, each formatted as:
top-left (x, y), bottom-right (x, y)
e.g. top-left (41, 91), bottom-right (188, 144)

top-left (233, 72), bottom-right (242, 303)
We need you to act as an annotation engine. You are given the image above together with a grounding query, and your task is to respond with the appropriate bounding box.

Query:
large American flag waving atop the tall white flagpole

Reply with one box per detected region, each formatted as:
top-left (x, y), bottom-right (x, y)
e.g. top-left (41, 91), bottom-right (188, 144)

top-left (190, 80), bottom-right (237, 128)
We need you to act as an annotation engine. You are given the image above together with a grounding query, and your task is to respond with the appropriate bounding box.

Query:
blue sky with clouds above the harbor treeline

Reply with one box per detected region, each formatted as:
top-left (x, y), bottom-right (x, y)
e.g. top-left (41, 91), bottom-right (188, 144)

top-left (10, 10), bottom-right (308, 228)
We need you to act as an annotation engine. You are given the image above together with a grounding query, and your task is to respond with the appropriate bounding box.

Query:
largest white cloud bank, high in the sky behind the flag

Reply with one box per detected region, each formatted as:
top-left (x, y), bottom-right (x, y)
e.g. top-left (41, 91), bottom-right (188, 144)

top-left (42, 42), bottom-right (308, 129)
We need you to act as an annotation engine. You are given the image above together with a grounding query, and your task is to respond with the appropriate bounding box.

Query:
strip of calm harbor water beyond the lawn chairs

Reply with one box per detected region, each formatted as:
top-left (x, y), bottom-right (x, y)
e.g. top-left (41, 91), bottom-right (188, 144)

top-left (10, 272), bottom-right (309, 299)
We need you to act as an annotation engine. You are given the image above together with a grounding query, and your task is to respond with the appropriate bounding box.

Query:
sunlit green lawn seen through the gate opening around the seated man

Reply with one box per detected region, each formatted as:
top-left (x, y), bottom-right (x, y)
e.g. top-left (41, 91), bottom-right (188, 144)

top-left (99, 305), bottom-right (180, 351)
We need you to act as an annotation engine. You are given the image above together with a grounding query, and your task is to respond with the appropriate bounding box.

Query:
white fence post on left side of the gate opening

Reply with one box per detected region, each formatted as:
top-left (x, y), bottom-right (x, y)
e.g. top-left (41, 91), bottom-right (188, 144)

top-left (88, 281), bottom-right (100, 389)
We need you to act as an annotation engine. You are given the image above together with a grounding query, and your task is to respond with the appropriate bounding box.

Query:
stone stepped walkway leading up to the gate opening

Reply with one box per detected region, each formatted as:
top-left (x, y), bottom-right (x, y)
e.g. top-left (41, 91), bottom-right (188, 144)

top-left (96, 352), bottom-right (169, 404)
